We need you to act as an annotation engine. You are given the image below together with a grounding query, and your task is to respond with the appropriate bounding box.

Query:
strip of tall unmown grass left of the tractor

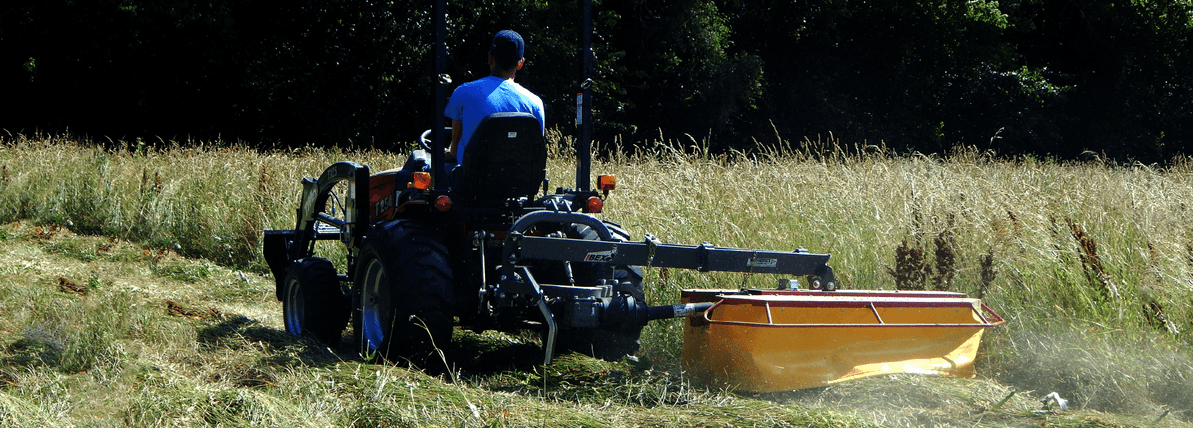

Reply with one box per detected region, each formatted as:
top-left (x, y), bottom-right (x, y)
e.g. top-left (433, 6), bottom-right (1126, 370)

top-left (0, 137), bottom-right (404, 271)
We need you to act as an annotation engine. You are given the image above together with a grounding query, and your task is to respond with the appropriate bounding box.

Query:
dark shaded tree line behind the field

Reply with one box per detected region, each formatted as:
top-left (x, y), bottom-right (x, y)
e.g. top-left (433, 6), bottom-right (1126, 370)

top-left (0, 0), bottom-right (1193, 161)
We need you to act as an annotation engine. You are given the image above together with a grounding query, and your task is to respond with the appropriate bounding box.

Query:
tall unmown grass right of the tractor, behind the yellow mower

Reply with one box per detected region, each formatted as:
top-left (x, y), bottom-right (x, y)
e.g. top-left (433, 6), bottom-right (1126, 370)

top-left (584, 134), bottom-right (1193, 419)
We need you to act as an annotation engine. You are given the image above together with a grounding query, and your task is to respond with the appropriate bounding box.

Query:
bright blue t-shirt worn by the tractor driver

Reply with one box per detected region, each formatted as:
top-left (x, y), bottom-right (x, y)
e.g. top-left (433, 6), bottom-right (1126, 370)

top-left (444, 76), bottom-right (546, 163)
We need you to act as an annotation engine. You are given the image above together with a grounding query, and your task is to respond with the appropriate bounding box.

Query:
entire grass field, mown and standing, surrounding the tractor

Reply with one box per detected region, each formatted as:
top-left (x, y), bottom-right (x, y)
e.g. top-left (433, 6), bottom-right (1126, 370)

top-left (0, 134), bottom-right (1193, 427)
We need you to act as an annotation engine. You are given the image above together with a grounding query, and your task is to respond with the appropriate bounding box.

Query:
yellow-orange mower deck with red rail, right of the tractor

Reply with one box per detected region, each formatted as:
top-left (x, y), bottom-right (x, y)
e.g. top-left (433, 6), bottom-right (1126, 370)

top-left (681, 290), bottom-right (1005, 392)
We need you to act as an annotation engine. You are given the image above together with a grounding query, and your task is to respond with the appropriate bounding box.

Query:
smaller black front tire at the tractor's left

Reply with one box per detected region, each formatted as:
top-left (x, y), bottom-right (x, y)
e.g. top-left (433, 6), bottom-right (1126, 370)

top-left (282, 258), bottom-right (351, 346)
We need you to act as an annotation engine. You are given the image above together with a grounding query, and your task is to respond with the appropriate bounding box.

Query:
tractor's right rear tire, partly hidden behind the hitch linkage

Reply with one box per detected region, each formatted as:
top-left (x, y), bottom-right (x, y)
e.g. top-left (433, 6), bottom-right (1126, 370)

top-left (557, 222), bottom-right (645, 361)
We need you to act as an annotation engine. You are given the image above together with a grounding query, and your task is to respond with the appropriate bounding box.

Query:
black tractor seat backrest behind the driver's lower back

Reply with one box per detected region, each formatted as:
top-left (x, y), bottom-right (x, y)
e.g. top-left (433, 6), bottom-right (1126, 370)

top-left (455, 113), bottom-right (546, 203)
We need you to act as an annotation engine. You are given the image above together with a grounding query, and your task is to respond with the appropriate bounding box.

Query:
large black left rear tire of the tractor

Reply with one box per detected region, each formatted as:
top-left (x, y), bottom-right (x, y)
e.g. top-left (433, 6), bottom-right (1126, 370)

top-left (353, 221), bottom-right (452, 368)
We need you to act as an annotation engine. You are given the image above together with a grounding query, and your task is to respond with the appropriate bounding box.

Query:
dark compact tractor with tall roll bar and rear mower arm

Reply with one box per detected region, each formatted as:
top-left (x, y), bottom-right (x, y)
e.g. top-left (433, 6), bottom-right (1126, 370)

top-left (264, 0), bottom-right (835, 364)
